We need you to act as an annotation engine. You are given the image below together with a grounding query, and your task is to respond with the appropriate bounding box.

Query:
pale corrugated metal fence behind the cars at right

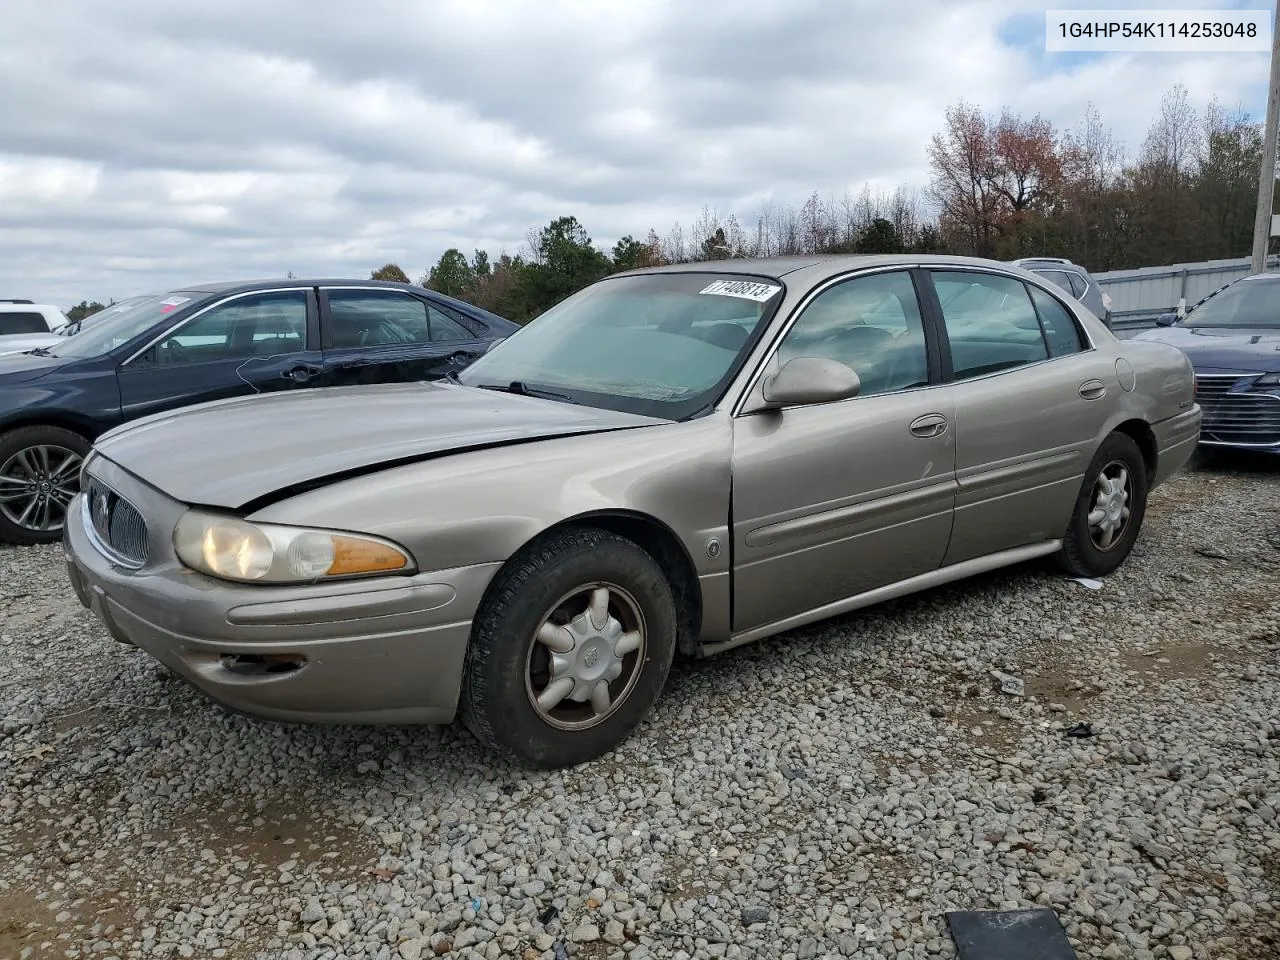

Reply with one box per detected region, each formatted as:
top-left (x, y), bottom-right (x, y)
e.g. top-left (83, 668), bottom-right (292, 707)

top-left (1093, 256), bottom-right (1280, 333)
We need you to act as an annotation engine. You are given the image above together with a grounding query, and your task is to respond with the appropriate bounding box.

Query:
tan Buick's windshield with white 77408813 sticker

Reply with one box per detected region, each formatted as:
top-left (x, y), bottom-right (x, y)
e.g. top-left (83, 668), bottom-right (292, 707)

top-left (458, 273), bottom-right (782, 420)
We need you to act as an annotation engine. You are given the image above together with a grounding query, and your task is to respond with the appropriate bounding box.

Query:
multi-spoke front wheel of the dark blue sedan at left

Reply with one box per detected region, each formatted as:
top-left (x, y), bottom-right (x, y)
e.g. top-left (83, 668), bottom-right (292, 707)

top-left (0, 426), bottom-right (90, 544)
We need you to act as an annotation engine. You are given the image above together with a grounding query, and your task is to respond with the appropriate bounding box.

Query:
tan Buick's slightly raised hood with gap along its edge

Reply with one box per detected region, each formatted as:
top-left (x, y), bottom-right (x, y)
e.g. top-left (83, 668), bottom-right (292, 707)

top-left (95, 383), bottom-right (667, 509)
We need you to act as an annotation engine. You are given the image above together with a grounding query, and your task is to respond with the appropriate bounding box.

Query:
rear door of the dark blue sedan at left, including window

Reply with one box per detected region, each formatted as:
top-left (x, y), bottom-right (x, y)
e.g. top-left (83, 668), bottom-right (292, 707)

top-left (320, 287), bottom-right (486, 387)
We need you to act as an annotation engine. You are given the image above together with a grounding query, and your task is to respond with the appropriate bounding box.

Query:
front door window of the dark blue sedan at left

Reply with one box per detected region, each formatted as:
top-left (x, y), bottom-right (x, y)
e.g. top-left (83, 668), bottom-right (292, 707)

top-left (136, 291), bottom-right (307, 366)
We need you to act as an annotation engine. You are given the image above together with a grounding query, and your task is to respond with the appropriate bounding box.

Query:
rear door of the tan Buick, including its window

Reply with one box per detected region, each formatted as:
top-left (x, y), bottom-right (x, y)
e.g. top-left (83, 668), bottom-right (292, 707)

top-left (929, 269), bottom-right (1120, 564)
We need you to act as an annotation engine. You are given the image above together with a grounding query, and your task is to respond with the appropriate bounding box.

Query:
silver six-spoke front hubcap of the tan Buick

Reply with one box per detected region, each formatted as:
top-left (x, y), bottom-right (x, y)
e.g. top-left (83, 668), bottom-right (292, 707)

top-left (525, 584), bottom-right (645, 730)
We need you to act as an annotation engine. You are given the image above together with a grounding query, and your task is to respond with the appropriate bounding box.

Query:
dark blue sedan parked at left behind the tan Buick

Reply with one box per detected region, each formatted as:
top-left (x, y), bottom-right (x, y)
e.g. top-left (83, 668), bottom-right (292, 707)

top-left (0, 279), bottom-right (518, 544)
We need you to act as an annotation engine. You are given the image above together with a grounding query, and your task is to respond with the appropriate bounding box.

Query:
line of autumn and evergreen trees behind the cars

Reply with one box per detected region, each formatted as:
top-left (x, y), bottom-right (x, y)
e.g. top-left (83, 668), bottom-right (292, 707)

top-left (374, 83), bottom-right (1262, 321)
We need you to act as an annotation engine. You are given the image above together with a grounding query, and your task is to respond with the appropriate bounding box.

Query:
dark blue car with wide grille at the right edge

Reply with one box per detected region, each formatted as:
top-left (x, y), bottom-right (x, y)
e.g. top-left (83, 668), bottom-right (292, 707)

top-left (1134, 274), bottom-right (1280, 453)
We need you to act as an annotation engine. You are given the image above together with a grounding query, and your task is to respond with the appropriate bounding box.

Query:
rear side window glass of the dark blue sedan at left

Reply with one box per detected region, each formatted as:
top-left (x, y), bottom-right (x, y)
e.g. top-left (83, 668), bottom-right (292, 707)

top-left (321, 291), bottom-right (475, 349)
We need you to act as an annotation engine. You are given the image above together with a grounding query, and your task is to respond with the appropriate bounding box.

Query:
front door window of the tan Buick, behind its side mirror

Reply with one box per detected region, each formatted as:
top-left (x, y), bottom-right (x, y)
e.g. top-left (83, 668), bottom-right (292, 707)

top-left (778, 271), bottom-right (929, 397)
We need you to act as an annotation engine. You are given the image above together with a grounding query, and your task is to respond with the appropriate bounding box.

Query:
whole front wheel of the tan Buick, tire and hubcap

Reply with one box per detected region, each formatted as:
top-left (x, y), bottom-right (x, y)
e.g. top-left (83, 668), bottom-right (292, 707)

top-left (461, 529), bottom-right (677, 768)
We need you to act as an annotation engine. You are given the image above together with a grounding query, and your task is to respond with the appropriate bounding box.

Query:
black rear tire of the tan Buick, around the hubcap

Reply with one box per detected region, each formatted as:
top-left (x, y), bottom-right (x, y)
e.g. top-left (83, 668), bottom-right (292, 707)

top-left (1059, 433), bottom-right (1148, 577)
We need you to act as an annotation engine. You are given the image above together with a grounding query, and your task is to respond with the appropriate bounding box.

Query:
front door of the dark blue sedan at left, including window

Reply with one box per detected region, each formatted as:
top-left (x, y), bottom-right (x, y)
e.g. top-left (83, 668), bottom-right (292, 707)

top-left (116, 288), bottom-right (321, 420)
